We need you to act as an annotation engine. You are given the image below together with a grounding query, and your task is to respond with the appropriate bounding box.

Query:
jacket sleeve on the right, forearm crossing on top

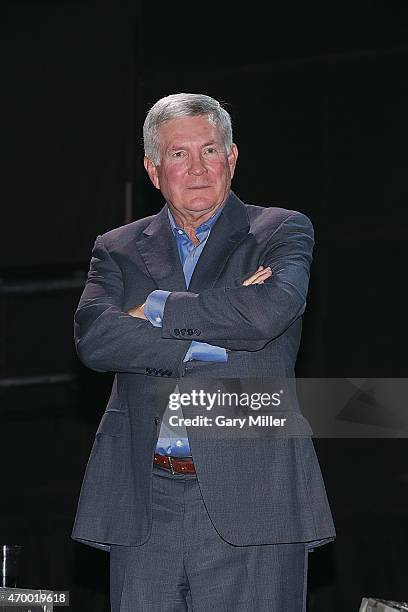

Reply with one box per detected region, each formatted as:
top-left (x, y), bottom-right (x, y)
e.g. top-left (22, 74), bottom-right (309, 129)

top-left (162, 212), bottom-right (314, 351)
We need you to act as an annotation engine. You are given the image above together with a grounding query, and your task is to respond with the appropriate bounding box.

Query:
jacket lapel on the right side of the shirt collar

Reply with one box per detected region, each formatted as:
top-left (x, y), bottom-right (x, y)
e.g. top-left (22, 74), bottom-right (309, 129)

top-left (188, 191), bottom-right (249, 293)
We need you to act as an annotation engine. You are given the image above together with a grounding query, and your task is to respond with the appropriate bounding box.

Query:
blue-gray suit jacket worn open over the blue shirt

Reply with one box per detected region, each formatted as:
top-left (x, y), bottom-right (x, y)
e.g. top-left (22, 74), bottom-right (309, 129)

top-left (72, 192), bottom-right (335, 549)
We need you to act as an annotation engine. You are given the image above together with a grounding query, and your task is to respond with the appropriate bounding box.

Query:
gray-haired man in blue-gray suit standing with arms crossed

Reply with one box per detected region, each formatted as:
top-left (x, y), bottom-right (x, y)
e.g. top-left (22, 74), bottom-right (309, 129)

top-left (72, 93), bottom-right (335, 612)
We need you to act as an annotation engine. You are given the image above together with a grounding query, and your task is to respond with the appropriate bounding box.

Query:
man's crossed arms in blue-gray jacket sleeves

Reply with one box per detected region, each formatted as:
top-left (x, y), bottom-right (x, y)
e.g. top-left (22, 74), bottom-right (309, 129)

top-left (74, 213), bottom-right (314, 373)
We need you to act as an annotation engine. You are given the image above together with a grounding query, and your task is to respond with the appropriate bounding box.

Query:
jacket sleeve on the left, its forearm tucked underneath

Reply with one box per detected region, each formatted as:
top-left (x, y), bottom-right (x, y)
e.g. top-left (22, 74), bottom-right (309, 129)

top-left (74, 236), bottom-right (188, 376)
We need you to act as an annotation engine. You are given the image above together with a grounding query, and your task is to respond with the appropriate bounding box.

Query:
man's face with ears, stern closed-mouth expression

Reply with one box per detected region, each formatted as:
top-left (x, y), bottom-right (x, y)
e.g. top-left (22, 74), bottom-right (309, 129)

top-left (145, 116), bottom-right (238, 220)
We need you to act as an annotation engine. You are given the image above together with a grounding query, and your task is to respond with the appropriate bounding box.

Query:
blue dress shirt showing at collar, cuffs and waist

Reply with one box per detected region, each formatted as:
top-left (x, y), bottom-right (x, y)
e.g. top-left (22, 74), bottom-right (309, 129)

top-left (144, 203), bottom-right (228, 457)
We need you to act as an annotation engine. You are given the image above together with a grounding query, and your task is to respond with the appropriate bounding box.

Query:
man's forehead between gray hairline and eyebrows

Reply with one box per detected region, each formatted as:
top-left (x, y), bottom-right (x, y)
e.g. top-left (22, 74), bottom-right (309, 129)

top-left (159, 115), bottom-right (222, 148)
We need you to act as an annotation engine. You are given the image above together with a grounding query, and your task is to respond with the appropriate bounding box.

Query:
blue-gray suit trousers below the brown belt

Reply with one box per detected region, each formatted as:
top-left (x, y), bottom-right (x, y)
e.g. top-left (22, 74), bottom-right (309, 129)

top-left (110, 467), bottom-right (308, 612)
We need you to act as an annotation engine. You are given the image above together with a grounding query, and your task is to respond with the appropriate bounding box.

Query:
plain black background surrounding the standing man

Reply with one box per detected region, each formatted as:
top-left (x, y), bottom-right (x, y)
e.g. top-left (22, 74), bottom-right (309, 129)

top-left (0, 0), bottom-right (408, 612)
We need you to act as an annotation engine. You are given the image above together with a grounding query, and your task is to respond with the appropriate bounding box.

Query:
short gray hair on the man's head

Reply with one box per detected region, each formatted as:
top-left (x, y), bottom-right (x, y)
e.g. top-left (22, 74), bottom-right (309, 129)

top-left (143, 93), bottom-right (232, 166)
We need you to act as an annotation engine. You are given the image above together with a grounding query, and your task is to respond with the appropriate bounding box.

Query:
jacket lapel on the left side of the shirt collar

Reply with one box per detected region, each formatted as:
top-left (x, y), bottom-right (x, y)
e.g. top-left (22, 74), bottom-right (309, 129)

top-left (136, 204), bottom-right (187, 291)
